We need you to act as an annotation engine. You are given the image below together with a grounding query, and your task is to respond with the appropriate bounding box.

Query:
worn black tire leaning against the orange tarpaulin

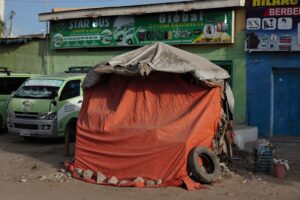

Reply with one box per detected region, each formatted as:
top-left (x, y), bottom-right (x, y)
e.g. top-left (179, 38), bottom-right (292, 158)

top-left (188, 147), bottom-right (220, 184)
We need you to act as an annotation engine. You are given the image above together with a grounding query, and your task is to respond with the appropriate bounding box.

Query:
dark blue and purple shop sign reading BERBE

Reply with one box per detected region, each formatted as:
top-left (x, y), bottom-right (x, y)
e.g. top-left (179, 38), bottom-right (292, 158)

top-left (245, 0), bottom-right (300, 51)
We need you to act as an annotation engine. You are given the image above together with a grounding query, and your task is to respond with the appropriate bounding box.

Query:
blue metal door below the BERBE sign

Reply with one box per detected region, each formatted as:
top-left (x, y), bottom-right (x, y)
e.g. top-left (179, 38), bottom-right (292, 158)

top-left (273, 70), bottom-right (300, 136)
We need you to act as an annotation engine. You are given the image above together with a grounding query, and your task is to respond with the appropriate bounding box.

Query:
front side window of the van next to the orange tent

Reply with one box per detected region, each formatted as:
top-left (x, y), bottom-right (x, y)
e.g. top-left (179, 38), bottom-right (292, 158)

top-left (59, 80), bottom-right (80, 101)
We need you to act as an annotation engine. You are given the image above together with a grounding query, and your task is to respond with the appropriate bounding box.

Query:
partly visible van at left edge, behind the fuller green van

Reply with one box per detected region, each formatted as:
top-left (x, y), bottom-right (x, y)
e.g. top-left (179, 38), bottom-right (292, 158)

top-left (0, 67), bottom-right (35, 129)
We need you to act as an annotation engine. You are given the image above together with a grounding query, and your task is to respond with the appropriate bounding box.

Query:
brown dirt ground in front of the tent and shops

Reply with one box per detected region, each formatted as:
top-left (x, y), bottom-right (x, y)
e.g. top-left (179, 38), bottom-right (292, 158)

top-left (0, 134), bottom-right (300, 200)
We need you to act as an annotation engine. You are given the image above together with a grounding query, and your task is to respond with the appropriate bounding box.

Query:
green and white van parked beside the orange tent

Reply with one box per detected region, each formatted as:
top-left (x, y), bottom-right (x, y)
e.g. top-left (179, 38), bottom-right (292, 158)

top-left (7, 68), bottom-right (86, 140)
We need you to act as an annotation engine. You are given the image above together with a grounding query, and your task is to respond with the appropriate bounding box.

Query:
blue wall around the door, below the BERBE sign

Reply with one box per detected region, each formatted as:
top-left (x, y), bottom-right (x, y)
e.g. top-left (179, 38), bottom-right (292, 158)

top-left (246, 52), bottom-right (300, 137)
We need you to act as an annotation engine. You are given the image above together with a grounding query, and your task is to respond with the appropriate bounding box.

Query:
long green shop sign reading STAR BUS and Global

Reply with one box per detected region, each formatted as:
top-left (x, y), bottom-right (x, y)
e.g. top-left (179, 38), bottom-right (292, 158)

top-left (50, 10), bottom-right (234, 49)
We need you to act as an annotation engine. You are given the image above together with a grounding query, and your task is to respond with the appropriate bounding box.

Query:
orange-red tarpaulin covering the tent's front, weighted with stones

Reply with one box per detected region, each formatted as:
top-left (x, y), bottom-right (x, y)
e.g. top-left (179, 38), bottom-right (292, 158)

top-left (72, 72), bottom-right (221, 189)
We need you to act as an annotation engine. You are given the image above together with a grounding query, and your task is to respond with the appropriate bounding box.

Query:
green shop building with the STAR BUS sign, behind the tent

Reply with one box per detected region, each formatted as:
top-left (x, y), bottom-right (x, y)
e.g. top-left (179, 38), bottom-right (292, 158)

top-left (0, 0), bottom-right (246, 123)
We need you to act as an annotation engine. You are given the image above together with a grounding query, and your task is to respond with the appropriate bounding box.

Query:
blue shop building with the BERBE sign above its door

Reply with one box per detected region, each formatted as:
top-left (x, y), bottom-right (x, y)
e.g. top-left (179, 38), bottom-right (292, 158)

top-left (245, 0), bottom-right (300, 137)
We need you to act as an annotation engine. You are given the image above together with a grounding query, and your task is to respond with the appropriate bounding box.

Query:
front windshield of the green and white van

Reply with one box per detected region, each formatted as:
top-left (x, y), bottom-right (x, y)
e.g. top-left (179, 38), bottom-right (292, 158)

top-left (14, 85), bottom-right (59, 99)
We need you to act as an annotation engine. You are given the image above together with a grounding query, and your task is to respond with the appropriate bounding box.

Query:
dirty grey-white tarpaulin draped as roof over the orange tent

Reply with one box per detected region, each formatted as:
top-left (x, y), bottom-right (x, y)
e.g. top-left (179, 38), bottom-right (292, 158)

top-left (82, 42), bottom-right (234, 118)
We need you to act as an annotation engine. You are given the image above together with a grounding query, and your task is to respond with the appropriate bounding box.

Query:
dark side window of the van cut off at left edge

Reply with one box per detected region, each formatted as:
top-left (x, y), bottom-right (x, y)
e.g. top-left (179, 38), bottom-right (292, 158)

top-left (0, 77), bottom-right (28, 95)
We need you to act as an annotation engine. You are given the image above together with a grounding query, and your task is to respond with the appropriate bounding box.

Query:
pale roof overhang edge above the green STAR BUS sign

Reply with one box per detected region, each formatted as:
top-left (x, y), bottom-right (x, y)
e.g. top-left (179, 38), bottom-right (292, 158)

top-left (39, 0), bottom-right (245, 21)
